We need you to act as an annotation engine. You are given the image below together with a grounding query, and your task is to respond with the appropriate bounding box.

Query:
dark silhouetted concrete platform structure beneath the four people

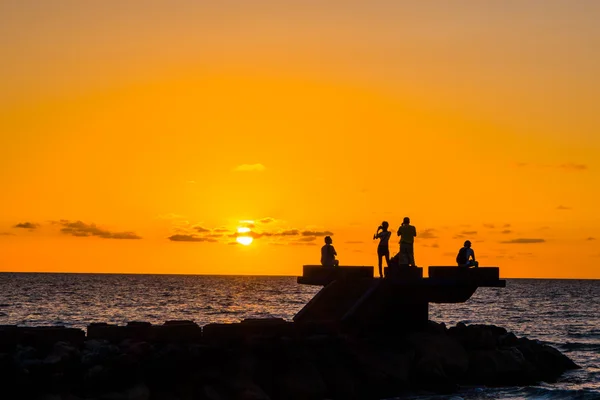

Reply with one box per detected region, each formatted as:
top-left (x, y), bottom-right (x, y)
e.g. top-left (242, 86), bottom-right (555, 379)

top-left (294, 265), bottom-right (506, 329)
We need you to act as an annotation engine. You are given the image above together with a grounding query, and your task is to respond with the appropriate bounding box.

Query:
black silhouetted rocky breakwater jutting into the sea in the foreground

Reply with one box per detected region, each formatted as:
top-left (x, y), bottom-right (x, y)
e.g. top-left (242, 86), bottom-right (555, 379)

top-left (0, 319), bottom-right (579, 400)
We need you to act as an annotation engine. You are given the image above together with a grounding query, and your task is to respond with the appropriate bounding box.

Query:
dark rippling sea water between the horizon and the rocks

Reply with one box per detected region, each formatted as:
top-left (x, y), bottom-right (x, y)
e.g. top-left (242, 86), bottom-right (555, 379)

top-left (0, 273), bottom-right (600, 400)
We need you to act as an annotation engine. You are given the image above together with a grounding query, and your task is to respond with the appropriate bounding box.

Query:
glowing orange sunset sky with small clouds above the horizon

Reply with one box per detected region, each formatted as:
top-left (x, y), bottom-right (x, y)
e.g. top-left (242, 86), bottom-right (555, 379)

top-left (0, 0), bottom-right (600, 278)
